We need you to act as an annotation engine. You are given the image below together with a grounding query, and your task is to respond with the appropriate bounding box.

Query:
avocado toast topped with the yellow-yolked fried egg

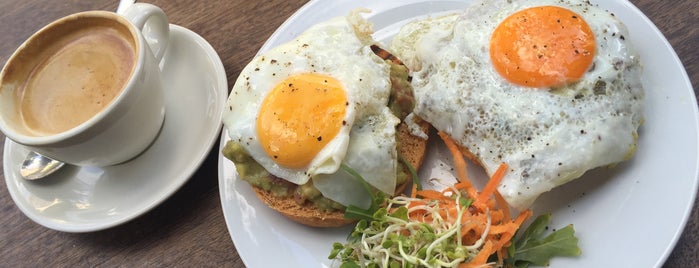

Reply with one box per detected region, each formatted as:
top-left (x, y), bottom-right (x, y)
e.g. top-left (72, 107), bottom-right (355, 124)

top-left (223, 10), bottom-right (428, 227)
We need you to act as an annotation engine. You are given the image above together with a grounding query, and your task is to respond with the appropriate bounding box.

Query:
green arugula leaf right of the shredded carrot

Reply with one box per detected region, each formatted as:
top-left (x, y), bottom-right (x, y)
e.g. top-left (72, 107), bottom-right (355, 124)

top-left (506, 214), bottom-right (582, 267)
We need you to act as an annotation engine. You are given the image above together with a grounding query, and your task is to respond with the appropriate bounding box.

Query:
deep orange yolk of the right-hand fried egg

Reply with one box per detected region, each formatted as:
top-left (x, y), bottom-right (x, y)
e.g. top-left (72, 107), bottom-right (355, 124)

top-left (490, 6), bottom-right (595, 88)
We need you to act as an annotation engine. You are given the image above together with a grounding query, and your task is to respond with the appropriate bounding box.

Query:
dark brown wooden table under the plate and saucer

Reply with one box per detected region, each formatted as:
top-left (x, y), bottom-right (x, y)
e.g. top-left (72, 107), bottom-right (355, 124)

top-left (0, 0), bottom-right (699, 267)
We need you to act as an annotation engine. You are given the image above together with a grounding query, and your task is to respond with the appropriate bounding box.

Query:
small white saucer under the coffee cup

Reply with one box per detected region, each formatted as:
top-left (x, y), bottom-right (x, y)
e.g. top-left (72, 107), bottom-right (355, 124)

top-left (3, 25), bottom-right (228, 232)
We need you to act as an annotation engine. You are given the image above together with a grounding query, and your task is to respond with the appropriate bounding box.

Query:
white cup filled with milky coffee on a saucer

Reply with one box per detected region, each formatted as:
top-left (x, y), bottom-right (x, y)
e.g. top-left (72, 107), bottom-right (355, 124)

top-left (0, 3), bottom-right (169, 166)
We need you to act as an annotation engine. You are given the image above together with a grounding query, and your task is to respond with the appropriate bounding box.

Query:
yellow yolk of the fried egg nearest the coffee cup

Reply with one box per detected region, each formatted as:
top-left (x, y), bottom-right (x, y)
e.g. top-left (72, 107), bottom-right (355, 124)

top-left (256, 73), bottom-right (348, 168)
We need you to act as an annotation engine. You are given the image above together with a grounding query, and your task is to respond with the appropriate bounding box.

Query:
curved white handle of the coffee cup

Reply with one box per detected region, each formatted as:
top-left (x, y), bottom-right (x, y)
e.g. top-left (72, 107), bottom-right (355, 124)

top-left (123, 3), bottom-right (170, 62)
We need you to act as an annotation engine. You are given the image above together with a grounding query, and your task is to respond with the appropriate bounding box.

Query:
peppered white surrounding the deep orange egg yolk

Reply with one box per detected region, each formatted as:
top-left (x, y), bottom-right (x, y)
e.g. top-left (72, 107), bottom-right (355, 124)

top-left (391, 0), bottom-right (644, 208)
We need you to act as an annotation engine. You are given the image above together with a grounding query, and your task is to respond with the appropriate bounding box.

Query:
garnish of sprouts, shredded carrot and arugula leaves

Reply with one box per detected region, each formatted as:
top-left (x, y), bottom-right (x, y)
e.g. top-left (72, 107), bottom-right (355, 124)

top-left (329, 132), bottom-right (581, 268)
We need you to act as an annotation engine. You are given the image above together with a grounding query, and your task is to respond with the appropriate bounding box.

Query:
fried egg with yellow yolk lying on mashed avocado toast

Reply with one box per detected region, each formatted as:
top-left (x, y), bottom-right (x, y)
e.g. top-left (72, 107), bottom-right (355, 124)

top-left (223, 11), bottom-right (399, 207)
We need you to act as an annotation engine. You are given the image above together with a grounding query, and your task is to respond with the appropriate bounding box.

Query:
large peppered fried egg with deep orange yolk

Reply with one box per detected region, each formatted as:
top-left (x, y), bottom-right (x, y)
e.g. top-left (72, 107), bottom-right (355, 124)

top-left (391, 0), bottom-right (644, 209)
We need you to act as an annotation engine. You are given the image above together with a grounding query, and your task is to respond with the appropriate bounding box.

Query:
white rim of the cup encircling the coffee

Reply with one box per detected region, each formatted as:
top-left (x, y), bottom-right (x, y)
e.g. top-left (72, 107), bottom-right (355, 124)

top-left (0, 10), bottom-right (146, 146)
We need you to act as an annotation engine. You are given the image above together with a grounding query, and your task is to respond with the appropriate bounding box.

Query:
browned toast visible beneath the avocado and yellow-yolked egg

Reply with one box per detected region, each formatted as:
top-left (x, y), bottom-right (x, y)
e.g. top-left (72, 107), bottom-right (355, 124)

top-left (252, 121), bottom-right (430, 227)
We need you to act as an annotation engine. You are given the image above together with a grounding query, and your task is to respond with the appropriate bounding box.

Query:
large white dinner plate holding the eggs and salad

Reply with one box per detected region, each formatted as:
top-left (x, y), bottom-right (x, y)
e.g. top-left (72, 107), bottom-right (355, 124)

top-left (219, 0), bottom-right (699, 267)
